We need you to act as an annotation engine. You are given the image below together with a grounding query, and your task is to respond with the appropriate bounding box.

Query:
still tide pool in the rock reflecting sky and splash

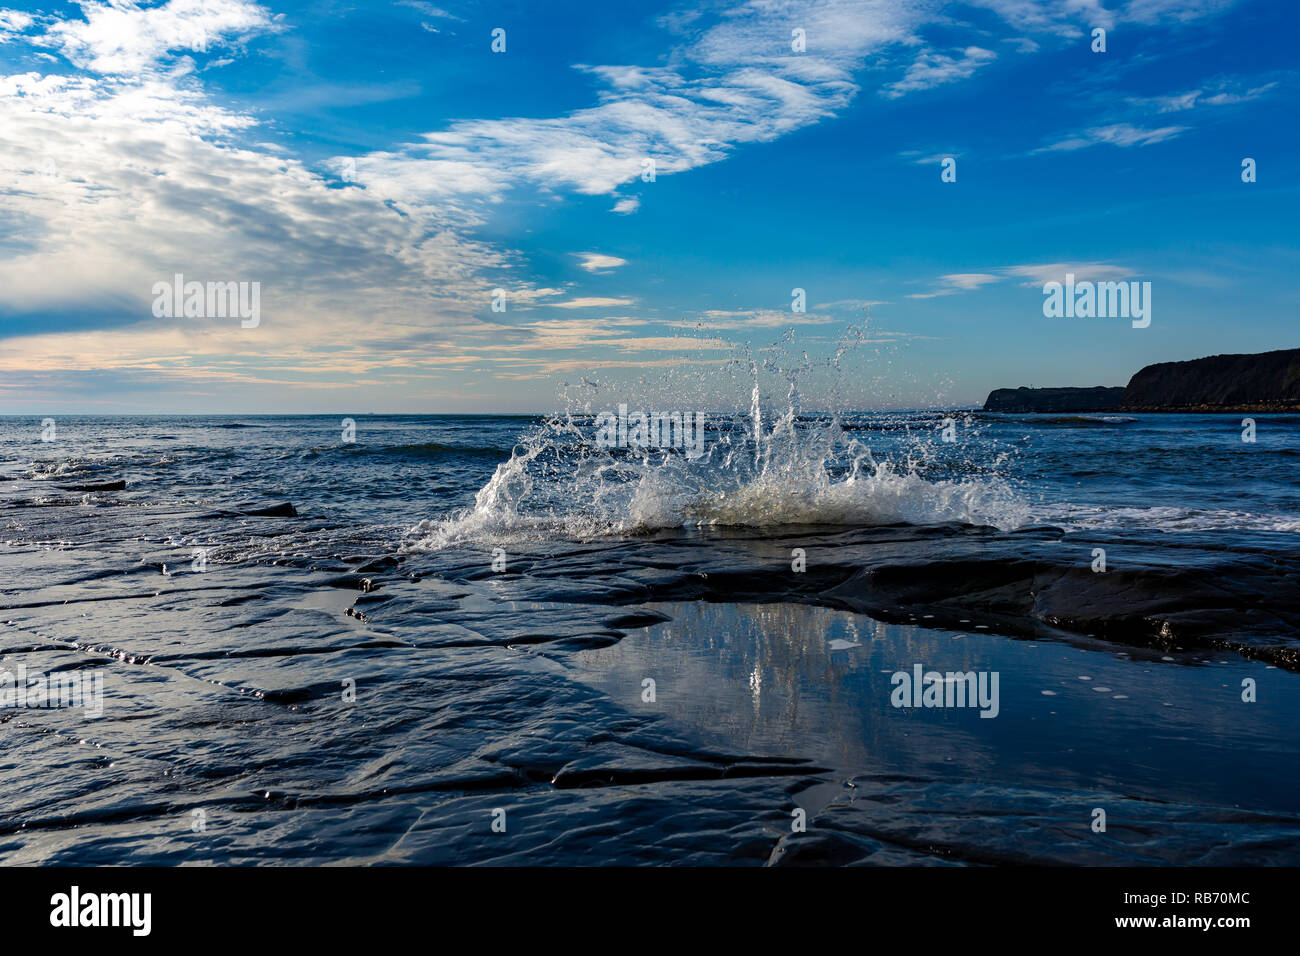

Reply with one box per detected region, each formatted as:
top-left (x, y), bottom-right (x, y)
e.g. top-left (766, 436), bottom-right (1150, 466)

top-left (571, 602), bottom-right (1300, 810)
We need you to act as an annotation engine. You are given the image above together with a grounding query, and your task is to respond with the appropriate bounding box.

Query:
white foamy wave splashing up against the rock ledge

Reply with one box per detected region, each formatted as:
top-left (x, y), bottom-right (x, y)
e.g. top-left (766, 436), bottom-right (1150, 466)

top-left (406, 410), bottom-right (1028, 550)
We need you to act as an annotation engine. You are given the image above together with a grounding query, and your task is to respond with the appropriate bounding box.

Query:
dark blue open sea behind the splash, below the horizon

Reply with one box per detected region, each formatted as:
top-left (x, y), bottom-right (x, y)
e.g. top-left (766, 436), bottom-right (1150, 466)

top-left (0, 412), bottom-right (1300, 536)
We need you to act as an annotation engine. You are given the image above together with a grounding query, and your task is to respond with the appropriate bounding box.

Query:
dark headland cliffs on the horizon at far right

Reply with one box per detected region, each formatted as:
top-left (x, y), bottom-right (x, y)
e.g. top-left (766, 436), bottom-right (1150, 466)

top-left (984, 349), bottom-right (1300, 414)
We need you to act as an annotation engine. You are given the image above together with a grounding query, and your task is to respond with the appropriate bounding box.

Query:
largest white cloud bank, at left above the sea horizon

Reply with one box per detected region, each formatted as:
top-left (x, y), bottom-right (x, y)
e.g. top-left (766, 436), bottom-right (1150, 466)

top-left (0, 65), bottom-right (512, 386)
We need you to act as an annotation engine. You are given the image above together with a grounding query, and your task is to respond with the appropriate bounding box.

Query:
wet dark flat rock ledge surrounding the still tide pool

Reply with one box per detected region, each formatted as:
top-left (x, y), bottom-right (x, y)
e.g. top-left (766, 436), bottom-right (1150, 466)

top-left (0, 494), bottom-right (1300, 865)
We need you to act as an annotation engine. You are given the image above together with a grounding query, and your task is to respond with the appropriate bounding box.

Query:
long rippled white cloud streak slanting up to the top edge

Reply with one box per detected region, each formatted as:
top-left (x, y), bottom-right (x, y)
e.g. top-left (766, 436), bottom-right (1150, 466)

top-left (340, 0), bottom-right (940, 205)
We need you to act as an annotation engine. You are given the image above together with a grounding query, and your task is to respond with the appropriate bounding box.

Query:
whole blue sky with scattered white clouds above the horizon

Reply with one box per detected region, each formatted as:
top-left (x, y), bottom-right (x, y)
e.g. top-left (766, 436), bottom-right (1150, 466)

top-left (0, 0), bottom-right (1300, 414)
